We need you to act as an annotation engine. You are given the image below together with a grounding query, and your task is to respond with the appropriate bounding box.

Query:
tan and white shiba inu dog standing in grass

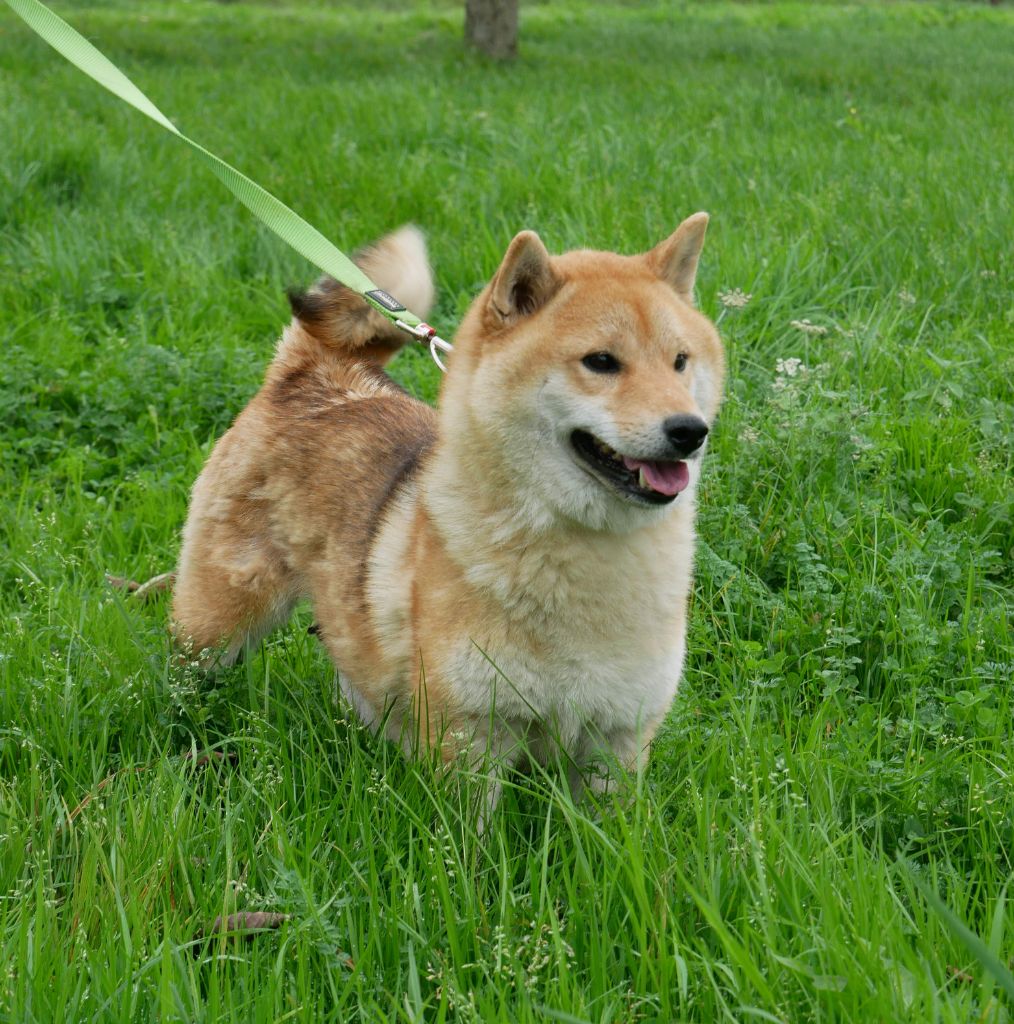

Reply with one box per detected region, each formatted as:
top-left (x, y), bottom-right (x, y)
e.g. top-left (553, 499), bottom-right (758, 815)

top-left (173, 213), bottom-right (724, 799)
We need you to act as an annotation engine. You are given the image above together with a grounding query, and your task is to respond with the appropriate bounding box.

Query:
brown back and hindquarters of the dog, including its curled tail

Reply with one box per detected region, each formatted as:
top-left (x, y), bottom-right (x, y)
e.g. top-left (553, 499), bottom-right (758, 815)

top-left (173, 227), bottom-right (435, 664)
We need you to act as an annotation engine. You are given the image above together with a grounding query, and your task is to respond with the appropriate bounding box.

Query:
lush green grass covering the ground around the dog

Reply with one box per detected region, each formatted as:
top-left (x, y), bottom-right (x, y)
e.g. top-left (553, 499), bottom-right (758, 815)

top-left (0, 0), bottom-right (1014, 1024)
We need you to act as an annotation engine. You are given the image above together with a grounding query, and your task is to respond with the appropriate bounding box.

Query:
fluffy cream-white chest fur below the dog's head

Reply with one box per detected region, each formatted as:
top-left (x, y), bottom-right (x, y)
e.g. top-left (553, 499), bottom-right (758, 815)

top-left (438, 501), bottom-right (692, 740)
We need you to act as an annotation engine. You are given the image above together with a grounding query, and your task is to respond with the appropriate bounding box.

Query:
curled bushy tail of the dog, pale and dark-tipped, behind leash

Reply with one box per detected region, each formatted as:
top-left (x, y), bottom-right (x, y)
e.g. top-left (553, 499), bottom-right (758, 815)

top-left (279, 224), bottom-right (434, 366)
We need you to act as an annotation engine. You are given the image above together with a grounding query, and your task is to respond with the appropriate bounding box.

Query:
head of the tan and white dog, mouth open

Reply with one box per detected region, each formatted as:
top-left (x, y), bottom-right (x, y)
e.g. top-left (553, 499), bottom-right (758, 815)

top-left (440, 213), bottom-right (724, 530)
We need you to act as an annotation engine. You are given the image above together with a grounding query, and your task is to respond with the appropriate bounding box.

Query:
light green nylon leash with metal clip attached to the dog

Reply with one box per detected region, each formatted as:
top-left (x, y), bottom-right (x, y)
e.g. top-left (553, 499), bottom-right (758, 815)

top-left (6, 0), bottom-right (451, 370)
